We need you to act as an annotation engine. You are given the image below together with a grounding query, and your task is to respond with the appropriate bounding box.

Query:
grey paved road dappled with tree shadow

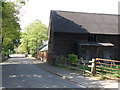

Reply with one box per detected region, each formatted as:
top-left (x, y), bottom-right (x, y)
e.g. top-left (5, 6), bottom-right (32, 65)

top-left (1, 54), bottom-right (81, 88)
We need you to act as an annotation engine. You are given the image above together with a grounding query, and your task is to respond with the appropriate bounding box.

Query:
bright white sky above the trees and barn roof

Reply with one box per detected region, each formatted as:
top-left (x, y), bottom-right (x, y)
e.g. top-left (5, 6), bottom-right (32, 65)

top-left (20, 0), bottom-right (120, 29)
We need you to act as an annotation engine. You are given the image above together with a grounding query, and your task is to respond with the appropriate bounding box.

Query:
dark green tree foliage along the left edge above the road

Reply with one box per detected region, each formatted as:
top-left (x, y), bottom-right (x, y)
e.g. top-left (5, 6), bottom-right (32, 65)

top-left (2, 2), bottom-right (20, 54)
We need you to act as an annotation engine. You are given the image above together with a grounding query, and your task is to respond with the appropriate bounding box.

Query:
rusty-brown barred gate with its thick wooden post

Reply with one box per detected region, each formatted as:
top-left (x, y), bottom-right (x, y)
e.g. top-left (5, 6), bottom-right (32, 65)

top-left (90, 58), bottom-right (120, 76)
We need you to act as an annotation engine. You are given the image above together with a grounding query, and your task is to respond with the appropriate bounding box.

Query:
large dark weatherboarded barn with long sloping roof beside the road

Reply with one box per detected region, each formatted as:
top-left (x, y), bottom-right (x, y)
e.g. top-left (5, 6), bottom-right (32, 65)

top-left (48, 11), bottom-right (120, 62)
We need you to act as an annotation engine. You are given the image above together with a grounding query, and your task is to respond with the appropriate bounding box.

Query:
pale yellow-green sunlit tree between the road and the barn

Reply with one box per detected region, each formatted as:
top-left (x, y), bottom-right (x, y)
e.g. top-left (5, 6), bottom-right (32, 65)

top-left (21, 20), bottom-right (48, 55)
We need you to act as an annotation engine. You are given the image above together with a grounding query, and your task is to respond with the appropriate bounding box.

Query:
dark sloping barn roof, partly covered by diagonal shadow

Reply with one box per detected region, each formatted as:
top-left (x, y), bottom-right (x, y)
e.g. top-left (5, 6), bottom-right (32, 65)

top-left (50, 10), bottom-right (120, 35)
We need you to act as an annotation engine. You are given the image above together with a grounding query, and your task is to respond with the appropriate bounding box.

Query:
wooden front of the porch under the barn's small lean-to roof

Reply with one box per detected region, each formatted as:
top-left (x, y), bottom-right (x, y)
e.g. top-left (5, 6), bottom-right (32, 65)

top-left (79, 46), bottom-right (114, 61)
